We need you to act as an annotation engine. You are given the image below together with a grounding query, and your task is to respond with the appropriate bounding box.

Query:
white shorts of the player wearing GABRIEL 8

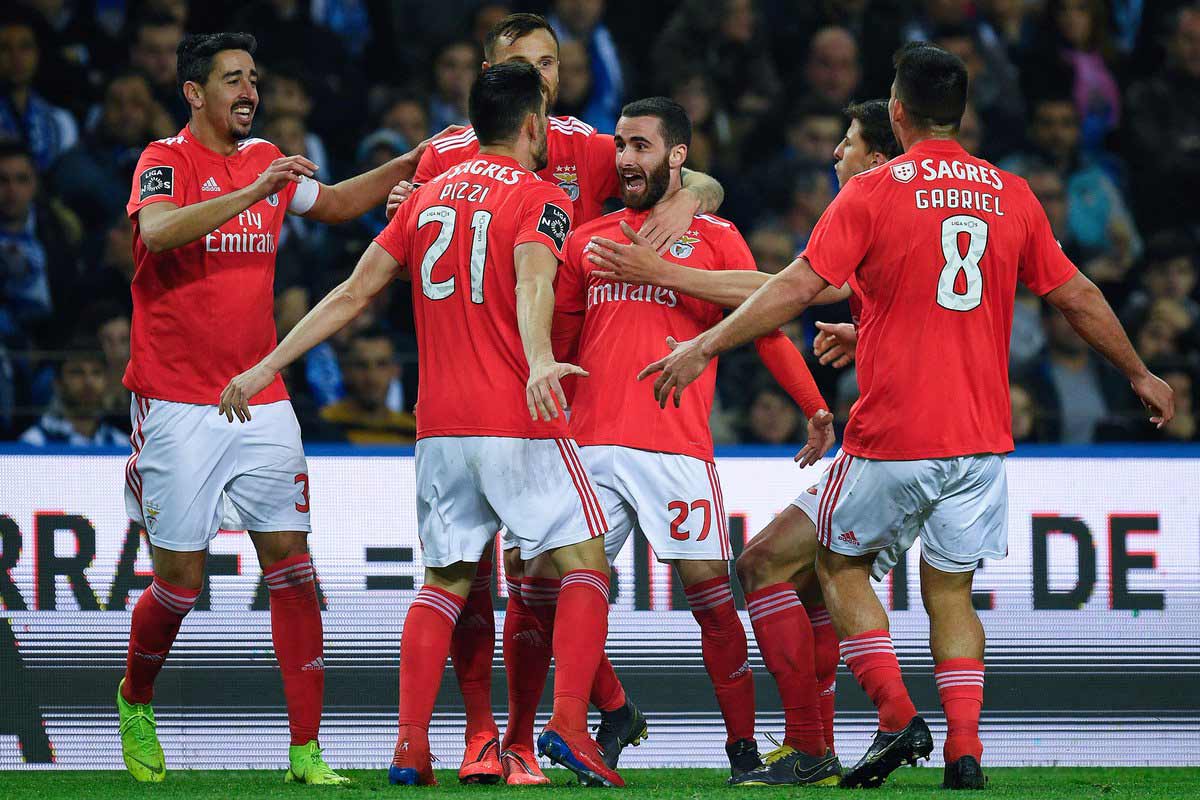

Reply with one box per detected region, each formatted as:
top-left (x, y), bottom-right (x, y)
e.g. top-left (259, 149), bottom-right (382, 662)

top-left (792, 452), bottom-right (1008, 581)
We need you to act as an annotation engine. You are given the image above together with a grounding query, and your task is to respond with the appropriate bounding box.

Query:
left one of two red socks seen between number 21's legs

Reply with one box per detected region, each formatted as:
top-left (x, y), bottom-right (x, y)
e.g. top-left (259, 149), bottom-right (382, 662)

top-left (450, 560), bottom-right (498, 741)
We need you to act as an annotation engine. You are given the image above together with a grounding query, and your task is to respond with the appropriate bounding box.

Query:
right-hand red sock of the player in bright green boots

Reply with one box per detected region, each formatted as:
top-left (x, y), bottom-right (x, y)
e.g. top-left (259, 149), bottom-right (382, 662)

top-left (263, 553), bottom-right (325, 745)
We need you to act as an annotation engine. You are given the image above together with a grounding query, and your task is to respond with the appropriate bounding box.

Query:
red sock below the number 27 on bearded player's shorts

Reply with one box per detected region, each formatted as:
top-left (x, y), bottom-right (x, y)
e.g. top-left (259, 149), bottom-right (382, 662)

top-left (684, 575), bottom-right (754, 741)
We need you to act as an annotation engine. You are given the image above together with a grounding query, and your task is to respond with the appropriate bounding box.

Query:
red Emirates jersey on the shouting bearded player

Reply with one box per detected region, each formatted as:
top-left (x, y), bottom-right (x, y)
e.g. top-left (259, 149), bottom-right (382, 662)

top-left (554, 209), bottom-right (755, 461)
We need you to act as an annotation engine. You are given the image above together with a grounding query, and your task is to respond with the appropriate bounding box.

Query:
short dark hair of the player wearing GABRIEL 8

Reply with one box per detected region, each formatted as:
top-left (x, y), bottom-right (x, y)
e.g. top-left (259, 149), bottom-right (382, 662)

top-left (893, 42), bottom-right (967, 130)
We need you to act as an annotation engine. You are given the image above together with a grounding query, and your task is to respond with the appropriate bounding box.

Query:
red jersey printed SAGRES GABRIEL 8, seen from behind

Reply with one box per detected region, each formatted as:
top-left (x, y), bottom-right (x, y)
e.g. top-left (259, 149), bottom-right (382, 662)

top-left (802, 139), bottom-right (1076, 461)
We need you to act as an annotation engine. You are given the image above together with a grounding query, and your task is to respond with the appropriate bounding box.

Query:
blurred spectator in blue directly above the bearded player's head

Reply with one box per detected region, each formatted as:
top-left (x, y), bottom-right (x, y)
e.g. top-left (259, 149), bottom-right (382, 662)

top-left (547, 0), bottom-right (625, 131)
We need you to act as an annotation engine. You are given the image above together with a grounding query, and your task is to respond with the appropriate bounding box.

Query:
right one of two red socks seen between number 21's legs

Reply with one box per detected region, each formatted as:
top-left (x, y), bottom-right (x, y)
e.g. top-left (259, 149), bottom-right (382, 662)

top-left (503, 578), bottom-right (558, 750)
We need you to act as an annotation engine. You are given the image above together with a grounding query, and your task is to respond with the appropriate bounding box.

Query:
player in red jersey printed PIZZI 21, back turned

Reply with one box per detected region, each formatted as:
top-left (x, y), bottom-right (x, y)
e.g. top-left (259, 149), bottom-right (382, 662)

top-left (222, 64), bottom-right (623, 786)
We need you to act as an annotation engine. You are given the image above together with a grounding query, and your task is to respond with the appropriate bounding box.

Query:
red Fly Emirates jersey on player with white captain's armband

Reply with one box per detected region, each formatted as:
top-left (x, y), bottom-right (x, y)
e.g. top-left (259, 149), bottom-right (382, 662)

top-left (124, 127), bottom-right (319, 405)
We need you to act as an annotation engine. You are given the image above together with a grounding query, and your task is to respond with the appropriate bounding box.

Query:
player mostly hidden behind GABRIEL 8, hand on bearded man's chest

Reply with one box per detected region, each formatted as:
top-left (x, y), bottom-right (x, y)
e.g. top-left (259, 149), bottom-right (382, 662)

top-left (588, 100), bottom-right (900, 786)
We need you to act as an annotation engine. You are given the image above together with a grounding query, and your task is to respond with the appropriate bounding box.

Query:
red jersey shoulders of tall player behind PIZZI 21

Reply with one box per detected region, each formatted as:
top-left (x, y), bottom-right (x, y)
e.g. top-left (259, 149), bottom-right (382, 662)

top-left (413, 116), bottom-right (620, 224)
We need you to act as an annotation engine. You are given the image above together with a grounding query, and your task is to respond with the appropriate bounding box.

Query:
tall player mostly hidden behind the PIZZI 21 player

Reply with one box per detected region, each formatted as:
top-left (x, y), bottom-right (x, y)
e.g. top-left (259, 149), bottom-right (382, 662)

top-left (389, 13), bottom-right (724, 784)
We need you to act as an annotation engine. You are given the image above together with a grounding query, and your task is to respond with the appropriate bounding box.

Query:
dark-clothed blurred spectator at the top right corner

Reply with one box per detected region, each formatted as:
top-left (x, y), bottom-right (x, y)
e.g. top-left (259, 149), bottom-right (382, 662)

top-left (1126, 2), bottom-right (1200, 230)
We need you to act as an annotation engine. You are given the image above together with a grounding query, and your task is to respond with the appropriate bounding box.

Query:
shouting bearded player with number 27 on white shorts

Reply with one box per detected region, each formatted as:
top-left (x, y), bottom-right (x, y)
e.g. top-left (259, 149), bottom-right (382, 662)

top-left (556, 97), bottom-right (839, 782)
